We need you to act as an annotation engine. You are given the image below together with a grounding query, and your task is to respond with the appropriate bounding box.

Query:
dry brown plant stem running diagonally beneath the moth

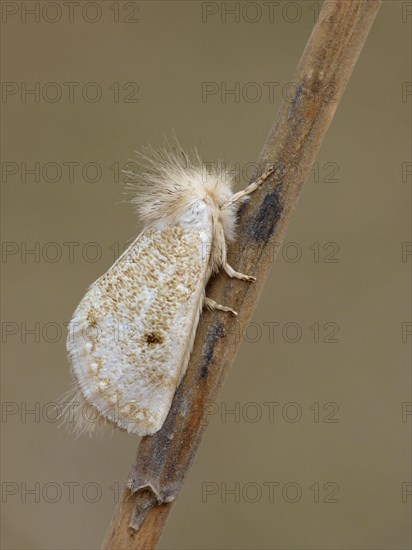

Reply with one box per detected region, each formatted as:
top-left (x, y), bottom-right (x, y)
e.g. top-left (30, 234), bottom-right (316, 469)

top-left (103, 0), bottom-right (380, 550)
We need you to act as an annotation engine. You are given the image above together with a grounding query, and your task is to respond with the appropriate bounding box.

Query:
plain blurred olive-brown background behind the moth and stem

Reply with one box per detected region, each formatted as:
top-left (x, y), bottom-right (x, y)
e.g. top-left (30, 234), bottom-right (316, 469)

top-left (1, 1), bottom-right (412, 550)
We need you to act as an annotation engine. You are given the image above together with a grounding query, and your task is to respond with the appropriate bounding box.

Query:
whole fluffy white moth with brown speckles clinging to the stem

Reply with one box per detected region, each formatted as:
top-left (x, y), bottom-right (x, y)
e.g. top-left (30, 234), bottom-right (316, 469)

top-left (66, 144), bottom-right (273, 435)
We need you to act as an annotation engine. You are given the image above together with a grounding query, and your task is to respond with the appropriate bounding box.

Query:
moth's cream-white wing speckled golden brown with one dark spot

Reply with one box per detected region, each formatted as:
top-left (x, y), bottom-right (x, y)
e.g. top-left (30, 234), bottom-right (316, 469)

top-left (67, 225), bottom-right (212, 435)
